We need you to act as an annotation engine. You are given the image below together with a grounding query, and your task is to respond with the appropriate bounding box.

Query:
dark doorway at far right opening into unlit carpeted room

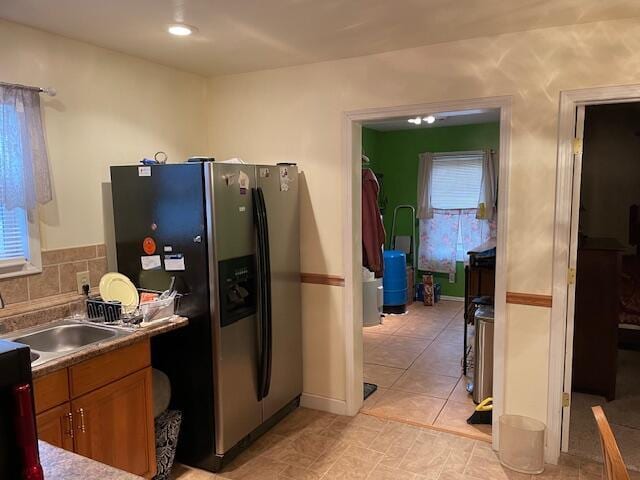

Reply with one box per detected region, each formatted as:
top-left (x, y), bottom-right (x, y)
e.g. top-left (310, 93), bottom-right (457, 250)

top-left (562, 101), bottom-right (640, 471)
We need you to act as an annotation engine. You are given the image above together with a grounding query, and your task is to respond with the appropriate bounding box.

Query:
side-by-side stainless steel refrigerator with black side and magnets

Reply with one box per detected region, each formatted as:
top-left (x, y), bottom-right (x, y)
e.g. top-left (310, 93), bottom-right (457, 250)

top-left (111, 162), bottom-right (302, 471)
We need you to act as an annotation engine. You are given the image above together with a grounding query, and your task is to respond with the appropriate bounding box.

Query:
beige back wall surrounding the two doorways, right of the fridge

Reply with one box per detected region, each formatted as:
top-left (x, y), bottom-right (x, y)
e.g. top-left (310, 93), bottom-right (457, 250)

top-left (209, 15), bottom-right (640, 421)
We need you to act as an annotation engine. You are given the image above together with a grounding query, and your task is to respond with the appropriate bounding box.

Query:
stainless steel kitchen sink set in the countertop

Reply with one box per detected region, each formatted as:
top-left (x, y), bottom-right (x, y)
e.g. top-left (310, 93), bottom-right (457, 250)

top-left (1, 319), bottom-right (133, 367)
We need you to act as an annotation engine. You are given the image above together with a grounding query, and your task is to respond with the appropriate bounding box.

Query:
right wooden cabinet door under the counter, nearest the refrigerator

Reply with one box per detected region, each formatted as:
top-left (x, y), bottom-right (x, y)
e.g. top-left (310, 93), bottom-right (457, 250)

top-left (71, 368), bottom-right (156, 477)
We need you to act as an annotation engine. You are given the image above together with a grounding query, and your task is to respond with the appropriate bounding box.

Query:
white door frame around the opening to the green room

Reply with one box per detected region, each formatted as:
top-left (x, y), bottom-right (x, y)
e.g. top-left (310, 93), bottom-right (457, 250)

top-left (342, 96), bottom-right (512, 448)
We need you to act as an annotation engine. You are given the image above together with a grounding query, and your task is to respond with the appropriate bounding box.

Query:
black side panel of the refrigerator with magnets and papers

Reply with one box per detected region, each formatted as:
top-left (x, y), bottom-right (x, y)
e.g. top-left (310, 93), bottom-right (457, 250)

top-left (111, 164), bottom-right (215, 464)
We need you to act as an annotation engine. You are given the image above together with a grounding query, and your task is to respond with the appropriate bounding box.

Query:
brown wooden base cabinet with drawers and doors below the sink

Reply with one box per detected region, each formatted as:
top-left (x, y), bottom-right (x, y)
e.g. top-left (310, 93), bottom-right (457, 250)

top-left (34, 341), bottom-right (156, 478)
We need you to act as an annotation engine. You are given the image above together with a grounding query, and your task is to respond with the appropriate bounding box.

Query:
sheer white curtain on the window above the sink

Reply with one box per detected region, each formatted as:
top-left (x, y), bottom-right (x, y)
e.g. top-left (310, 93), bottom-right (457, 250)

top-left (0, 86), bottom-right (52, 210)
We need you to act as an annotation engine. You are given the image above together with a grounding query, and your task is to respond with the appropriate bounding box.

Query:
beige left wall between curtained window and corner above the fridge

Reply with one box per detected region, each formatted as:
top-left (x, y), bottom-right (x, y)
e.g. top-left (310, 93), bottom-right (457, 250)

top-left (0, 20), bottom-right (206, 249)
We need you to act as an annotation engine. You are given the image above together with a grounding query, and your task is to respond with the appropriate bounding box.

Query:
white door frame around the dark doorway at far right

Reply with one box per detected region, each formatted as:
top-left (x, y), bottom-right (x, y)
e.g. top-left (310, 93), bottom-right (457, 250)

top-left (546, 85), bottom-right (640, 463)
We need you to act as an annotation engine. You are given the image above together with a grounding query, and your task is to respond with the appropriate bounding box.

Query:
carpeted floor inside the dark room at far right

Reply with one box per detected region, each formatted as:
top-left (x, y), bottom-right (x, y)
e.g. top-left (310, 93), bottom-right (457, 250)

top-left (569, 350), bottom-right (640, 471)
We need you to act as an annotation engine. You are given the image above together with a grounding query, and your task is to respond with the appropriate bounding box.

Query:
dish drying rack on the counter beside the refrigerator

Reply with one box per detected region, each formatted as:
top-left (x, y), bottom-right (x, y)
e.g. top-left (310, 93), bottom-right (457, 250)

top-left (86, 288), bottom-right (182, 327)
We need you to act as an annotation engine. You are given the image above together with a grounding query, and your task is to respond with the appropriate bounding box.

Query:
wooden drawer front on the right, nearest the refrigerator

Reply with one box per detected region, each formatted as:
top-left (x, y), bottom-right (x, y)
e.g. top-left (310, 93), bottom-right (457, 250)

top-left (69, 340), bottom-right (151, 398)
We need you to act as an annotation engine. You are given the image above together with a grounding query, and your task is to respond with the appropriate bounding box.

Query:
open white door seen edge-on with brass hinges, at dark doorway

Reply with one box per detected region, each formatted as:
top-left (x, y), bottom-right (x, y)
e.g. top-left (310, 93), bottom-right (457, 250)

top-left (562, 105), bottom-right (584, 452)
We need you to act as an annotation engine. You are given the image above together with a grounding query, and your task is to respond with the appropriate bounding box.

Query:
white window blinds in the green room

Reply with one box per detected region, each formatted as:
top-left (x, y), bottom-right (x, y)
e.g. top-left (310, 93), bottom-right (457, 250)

top-left (431, 152), bottom-right (483, 210)
